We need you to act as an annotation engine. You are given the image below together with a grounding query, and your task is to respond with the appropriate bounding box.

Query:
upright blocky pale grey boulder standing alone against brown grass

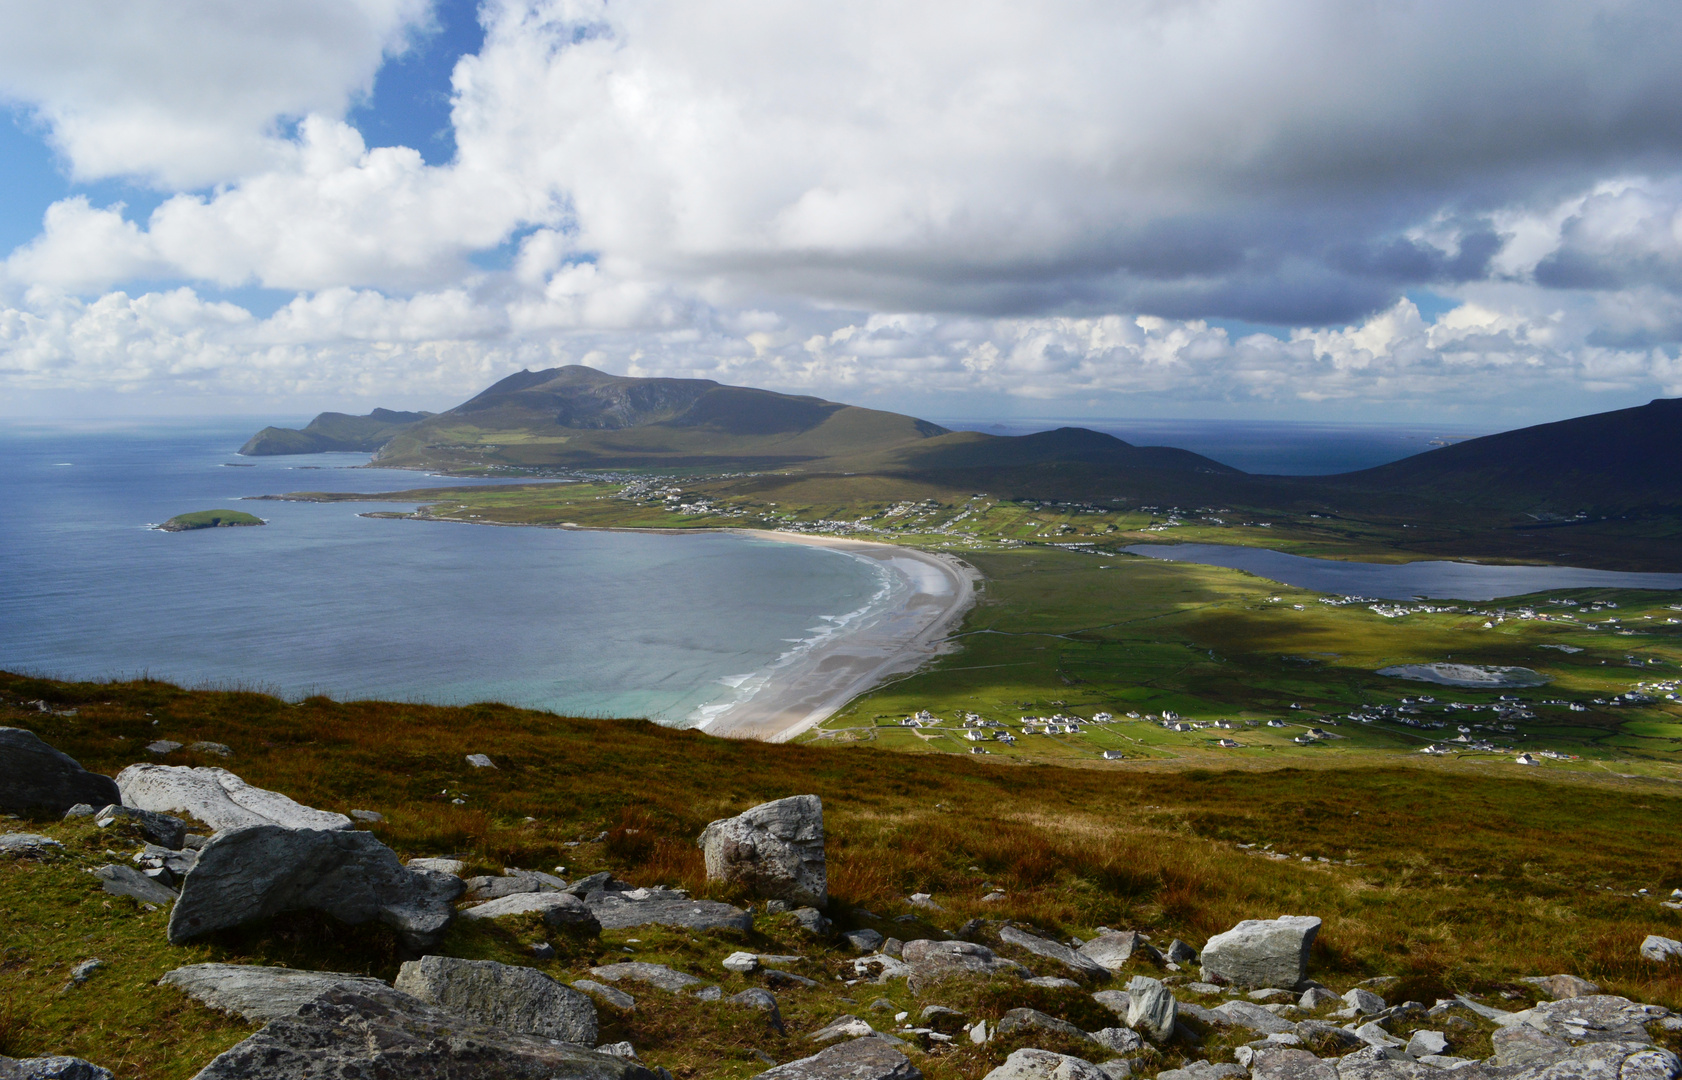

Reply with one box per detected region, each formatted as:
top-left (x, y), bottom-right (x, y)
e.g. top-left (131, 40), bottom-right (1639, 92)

top-left (698, 796), bottom-right (829, 907)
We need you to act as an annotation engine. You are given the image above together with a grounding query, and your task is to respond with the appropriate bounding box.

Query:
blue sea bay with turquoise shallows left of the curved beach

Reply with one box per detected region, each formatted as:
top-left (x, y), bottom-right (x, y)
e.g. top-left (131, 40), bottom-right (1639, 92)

top-left (0, 424), bottom-right (890, 725)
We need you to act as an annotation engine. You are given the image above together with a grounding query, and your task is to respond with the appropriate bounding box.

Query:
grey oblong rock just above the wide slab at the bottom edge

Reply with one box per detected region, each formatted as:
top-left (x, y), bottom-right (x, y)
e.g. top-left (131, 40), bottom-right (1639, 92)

top-left (392, 956), bottom-right (595, 1046)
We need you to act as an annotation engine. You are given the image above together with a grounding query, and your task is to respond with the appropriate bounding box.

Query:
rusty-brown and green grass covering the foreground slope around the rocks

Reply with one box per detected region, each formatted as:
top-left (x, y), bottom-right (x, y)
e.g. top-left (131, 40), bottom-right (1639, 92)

top-left (0, 675), bottom-right (1682, 1080)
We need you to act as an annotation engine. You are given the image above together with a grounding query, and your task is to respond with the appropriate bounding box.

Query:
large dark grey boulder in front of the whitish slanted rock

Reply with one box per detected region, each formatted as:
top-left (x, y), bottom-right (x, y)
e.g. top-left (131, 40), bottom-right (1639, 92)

top-left (166, 820), bottom-right (464, 950)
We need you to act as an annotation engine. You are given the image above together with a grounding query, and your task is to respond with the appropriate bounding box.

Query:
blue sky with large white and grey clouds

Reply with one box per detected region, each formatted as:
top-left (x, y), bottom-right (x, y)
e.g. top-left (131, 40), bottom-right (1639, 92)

top-left (0, 0), bottom-right (1682, 427)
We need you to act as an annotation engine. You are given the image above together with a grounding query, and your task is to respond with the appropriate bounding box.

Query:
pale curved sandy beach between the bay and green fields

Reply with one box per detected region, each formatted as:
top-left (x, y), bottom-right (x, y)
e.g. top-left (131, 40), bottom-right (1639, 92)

top-left (700, 530), bottom-right (981, 742)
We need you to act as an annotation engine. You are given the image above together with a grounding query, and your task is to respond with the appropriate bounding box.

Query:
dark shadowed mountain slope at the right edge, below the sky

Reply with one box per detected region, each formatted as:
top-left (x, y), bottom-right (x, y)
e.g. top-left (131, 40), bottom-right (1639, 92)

top-left (1324, 399), bottom-right (1682, 518)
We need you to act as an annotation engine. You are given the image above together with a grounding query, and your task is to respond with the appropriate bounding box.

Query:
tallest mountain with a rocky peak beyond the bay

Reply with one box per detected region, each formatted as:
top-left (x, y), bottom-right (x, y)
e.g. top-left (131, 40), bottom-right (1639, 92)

top-left (378, 365), bottom-right (947, 469)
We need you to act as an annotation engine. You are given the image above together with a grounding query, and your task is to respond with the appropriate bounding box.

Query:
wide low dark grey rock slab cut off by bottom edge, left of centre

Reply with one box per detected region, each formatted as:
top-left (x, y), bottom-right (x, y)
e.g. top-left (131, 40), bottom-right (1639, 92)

top-left (195, 986), bottom-right (658, 1080)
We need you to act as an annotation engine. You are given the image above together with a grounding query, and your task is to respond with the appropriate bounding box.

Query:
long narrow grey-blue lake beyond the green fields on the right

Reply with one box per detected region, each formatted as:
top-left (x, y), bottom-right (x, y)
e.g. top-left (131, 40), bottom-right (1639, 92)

top-left (1124, 543), bottom-right (1682, 601)
